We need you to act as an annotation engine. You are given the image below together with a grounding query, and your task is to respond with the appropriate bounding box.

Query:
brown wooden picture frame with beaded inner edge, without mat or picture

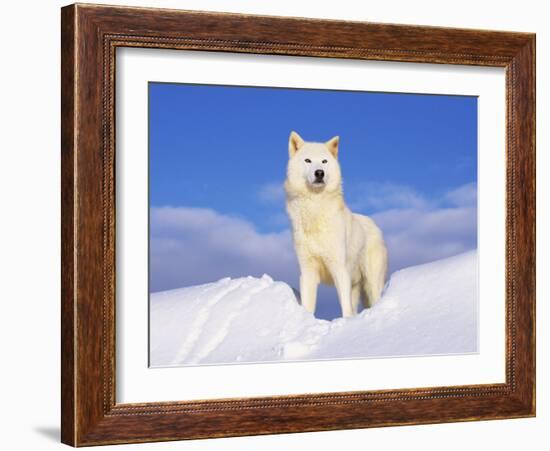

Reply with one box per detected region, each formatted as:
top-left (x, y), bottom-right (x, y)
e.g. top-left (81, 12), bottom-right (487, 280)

top-left (61, 4), bottom-right (535, 446)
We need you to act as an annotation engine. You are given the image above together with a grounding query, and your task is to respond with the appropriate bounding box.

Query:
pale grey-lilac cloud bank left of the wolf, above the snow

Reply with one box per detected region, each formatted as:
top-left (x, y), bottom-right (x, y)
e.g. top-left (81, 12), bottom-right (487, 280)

top-left (150, 207), bottom-right (298, 291)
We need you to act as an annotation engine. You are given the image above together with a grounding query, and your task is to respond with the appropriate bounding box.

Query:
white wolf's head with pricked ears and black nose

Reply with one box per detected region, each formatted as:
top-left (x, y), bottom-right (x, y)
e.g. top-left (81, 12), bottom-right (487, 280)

top-left (286, 132), bottom-right (342, 194)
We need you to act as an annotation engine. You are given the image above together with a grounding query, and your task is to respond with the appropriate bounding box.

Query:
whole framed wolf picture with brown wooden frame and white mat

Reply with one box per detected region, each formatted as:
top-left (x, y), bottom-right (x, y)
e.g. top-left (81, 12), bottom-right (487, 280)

top-left (61, 4), bottom-right (535, 446)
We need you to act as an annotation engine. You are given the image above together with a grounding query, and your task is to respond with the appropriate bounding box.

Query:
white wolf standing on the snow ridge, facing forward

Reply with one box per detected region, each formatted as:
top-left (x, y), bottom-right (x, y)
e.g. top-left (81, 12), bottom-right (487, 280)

top-left (285, 132), bottom-right (388, 317)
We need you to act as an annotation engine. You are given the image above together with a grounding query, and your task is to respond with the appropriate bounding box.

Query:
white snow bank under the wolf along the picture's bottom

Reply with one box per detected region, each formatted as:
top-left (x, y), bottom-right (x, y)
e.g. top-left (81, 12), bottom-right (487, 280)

top-left (150, 251), bottom-right (478, 367)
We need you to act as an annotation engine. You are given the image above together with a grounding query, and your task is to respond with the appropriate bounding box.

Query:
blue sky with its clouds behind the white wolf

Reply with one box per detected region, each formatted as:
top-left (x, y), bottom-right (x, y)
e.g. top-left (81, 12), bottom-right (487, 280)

top-left (149, 83), bottom-right (477, 318)
